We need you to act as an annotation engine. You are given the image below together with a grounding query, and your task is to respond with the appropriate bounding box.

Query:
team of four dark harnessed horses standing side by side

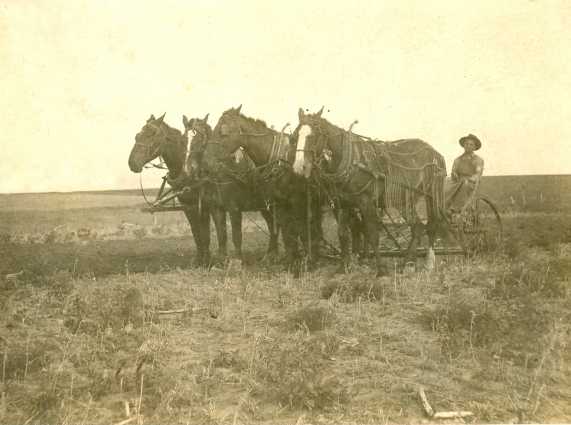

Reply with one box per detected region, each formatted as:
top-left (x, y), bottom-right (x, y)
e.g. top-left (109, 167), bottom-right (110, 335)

top-left (129, 106), bottom-right (446, 275)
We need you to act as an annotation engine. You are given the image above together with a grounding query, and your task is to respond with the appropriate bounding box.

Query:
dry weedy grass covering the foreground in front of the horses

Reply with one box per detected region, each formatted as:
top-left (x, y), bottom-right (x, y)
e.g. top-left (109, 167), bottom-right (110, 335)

top-left (0, 242), bottom-right (571, 423)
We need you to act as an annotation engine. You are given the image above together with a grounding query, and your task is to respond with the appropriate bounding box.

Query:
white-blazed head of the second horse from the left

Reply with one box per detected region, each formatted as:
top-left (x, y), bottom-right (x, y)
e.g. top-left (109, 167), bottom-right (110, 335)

top-left (182, 114), bottom-right (212, 176)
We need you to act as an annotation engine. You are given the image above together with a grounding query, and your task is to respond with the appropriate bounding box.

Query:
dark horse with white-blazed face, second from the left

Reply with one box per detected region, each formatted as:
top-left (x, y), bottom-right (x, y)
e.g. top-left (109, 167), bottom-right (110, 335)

top-left (183, 115), bottom-right (278, 260)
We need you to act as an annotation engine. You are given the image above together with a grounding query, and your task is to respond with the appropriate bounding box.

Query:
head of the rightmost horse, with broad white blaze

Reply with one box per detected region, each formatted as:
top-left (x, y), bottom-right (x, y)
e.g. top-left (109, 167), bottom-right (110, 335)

top-left (291, 108), bottom-right (327, 178)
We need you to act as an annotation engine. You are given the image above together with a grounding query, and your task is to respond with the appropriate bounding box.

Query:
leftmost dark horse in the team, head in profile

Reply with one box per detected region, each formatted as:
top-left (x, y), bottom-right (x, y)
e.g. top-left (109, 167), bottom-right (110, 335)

top-left (129, 114), bottom-right (210, 266)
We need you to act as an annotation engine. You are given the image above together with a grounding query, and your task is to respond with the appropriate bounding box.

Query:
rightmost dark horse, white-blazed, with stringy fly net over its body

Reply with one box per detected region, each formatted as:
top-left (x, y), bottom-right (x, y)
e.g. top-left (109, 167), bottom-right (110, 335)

top-left (292, 108), bottom-right (446, 276)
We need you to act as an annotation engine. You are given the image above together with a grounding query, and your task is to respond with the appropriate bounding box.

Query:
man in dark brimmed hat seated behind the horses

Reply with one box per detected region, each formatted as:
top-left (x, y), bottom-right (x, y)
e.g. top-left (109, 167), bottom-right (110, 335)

top-left (446, 134), bottom-right (484, 215)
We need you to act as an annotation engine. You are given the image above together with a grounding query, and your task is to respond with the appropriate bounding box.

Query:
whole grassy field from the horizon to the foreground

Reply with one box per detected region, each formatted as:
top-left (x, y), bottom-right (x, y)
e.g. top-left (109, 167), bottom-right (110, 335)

top-left (0, 176), bottom-right (571, 424)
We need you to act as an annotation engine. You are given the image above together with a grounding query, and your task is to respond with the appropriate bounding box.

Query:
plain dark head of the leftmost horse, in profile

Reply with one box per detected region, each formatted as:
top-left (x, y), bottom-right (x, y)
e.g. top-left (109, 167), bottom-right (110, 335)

top-left (129, 114), bottom-right (167, 173)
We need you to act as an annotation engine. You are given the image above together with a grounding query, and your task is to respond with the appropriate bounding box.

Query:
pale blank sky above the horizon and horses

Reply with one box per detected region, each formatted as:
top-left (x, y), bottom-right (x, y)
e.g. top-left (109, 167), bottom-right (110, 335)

top-left (0, 0), bottom-right (571, 193)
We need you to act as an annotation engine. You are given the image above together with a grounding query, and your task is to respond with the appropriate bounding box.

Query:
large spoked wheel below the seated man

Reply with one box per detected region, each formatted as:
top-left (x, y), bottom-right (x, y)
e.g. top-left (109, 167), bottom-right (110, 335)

top-left (453, 196), bottom-right (503, 255)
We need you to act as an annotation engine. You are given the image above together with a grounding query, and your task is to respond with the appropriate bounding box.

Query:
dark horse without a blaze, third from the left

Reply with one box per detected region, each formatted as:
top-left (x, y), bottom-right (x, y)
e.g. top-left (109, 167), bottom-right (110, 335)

top-left (204, 105), bottom-right (322, 275)
